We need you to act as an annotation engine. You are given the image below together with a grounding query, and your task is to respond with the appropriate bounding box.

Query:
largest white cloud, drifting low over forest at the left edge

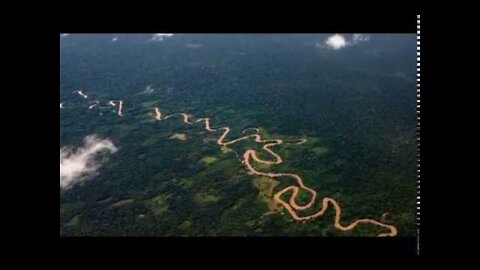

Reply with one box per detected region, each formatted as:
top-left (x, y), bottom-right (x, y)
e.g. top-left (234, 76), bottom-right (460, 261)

top-left (60, 135), bottom-right (117, 189)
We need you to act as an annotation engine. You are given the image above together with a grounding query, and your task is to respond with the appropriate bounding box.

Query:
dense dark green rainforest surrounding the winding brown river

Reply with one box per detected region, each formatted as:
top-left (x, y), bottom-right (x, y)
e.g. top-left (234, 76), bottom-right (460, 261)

top-left (60, 34), bottom-right (416, 236)
